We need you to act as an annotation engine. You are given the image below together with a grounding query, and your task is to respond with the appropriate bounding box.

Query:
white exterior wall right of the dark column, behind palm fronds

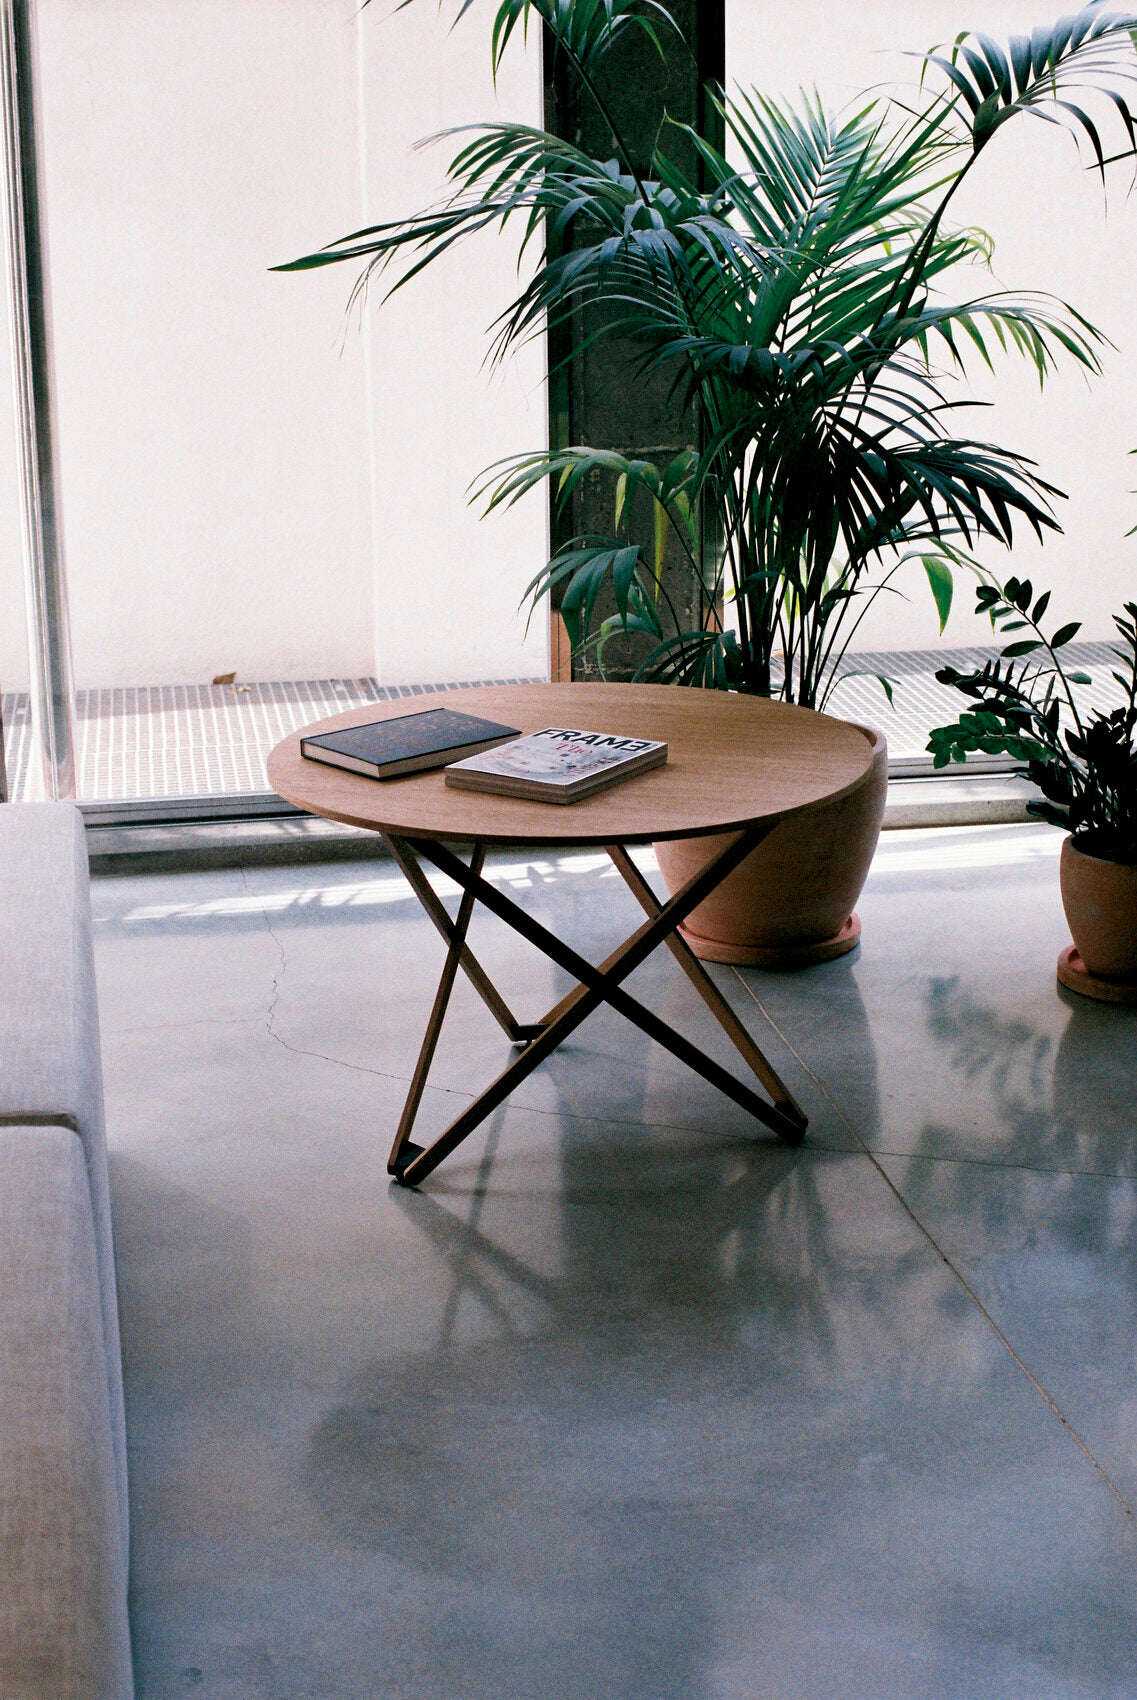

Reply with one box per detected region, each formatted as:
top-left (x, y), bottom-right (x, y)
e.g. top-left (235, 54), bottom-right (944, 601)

top-left (727, 0), bottom-right (1137, 649)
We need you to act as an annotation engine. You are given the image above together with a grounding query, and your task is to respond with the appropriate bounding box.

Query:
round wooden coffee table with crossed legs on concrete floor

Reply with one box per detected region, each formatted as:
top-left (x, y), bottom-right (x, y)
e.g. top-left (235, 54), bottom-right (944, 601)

top-left (269, 685), bottom-right (874, 1187)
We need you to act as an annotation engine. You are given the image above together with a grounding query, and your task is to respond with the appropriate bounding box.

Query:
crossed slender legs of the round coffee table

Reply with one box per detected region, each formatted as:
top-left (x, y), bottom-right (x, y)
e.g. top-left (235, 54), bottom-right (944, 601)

top-left (386, 825), bottom-right (806, 1187)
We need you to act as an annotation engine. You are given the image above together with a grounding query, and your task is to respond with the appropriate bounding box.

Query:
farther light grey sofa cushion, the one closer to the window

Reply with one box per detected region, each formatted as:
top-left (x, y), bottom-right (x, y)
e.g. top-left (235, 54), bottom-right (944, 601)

top-left (0, 802), bottom-right (129, 1550)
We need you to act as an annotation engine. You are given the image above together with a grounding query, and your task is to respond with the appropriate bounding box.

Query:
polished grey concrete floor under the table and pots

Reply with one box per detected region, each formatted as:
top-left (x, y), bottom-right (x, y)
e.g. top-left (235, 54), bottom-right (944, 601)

top-left (93, 826), bottom-right (1137, 1700)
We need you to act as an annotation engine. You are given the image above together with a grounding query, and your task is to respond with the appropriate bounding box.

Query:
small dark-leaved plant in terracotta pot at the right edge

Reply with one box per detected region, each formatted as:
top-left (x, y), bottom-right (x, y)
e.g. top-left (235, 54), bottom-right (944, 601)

top-left (928, 578), bottom-right (1137, 1003)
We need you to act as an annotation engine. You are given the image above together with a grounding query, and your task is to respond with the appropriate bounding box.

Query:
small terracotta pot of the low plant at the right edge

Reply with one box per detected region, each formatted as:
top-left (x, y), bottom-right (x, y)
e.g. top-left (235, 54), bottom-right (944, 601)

top-left (1059, 838), bottom-right (1137, 1003)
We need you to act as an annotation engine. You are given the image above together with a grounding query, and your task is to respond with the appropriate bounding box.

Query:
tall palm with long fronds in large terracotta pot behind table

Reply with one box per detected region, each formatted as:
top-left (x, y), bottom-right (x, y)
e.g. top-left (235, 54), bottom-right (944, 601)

top-left (278, 0), bottom-right (1137, 962)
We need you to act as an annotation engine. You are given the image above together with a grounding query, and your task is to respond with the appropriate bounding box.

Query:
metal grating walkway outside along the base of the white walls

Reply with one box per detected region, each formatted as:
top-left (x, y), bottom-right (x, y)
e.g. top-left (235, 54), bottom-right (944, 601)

top-left (3, 643), bottom-right (1118, 802)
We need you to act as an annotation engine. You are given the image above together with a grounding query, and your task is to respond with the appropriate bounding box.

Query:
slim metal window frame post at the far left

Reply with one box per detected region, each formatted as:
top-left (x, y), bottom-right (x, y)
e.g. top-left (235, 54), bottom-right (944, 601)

top-left (0, 0), bottom-right (75, 799)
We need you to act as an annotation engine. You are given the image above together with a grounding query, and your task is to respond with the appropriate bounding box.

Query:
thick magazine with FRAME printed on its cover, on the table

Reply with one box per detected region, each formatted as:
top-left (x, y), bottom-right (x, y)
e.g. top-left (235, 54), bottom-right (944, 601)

top-left (445, 726), bottom-right (668, 802)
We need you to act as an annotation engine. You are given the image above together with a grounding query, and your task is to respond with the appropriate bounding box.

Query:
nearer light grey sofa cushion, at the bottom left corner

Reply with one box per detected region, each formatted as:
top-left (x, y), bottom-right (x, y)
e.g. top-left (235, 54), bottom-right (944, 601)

top-left (0, 1127), bottom-right (133, 1700)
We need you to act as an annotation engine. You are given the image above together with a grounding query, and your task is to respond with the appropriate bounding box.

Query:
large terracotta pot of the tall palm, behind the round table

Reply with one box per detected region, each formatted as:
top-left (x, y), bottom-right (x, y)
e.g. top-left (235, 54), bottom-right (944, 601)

top-left (654, 726), bottom-right (889, 967)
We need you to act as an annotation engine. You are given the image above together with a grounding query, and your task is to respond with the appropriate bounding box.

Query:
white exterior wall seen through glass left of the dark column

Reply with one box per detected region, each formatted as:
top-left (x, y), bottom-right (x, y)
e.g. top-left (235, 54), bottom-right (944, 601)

top-left (0, 0), bottom-right (546, 689)
